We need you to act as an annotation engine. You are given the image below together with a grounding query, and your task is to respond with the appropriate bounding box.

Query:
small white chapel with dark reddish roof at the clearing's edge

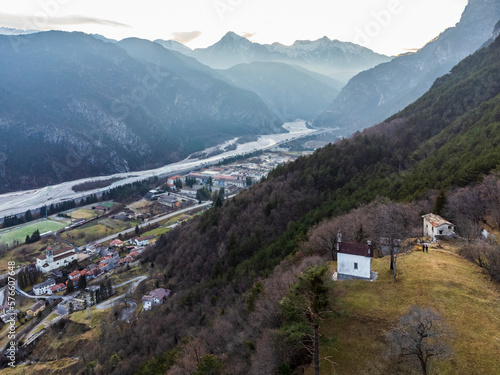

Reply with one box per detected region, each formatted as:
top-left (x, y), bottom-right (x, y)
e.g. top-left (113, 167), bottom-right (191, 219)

top-left (337, 233), bottom-right (373, 280)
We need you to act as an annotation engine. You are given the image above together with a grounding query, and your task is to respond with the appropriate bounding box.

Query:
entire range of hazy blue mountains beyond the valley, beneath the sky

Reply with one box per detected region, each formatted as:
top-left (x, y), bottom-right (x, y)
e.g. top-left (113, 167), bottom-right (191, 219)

top-left (0, 0), bottom-right (500, 192)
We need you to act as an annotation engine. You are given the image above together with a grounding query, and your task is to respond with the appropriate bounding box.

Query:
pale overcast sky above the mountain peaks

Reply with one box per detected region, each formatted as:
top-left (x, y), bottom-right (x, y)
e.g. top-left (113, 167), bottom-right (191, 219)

top-left (0, 0), bottom-right (467, 55)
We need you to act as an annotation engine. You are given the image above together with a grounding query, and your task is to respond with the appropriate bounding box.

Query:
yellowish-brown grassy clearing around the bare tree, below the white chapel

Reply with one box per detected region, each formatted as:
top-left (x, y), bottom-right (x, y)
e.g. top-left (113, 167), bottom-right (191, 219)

top-left (306, 244), bottom-right (500, 375)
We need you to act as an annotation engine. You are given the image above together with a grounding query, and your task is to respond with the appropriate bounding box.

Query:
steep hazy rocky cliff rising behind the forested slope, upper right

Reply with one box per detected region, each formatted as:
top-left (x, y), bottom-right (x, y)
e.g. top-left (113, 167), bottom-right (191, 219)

top-left (314, 0), bottom-right (500, 131)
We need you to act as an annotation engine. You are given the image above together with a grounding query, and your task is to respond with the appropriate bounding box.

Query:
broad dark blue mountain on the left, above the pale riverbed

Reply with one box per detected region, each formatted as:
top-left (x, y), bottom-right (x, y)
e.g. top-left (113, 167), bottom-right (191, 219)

top-left (0, 32), bottom-right (281, 191)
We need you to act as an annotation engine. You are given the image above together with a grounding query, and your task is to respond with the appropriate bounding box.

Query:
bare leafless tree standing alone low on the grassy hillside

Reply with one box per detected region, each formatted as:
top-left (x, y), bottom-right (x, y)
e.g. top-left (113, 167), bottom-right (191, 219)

top-left (387, 306), bottom-right (451, 375)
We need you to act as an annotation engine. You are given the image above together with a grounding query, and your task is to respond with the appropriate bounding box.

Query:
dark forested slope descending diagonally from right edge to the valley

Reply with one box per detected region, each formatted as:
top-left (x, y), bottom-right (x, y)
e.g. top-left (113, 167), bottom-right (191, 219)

top-left (64, 39), bottom-right (500, 374)
